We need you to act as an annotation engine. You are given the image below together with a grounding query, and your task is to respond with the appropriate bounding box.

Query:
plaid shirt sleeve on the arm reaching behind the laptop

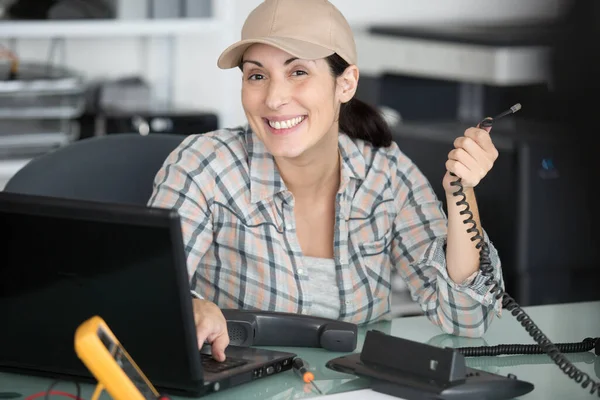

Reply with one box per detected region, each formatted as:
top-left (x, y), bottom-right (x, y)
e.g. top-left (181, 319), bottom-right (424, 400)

top-left (148, 136), bottom-right (213, 298)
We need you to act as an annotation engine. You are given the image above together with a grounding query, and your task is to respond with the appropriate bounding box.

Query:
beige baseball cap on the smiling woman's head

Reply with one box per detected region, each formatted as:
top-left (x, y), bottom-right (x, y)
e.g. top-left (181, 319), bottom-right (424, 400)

top-left (217, 0), bottom-right (356, 69)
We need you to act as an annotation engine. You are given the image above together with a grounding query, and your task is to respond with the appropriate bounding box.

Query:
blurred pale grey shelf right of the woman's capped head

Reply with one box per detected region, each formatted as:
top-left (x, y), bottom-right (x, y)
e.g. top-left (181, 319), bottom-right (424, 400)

top-left (356, 32), bottom-right (549, 86)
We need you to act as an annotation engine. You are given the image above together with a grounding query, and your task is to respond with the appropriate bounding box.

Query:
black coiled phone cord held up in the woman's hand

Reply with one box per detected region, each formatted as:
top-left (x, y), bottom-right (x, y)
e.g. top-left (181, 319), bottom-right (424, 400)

top-left (450, 104), bottom-right (600, 397)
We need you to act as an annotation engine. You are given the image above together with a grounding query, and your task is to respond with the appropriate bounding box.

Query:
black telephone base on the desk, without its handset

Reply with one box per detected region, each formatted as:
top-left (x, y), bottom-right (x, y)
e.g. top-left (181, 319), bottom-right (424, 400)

top-left (326, 331), bottom-right (534, 400)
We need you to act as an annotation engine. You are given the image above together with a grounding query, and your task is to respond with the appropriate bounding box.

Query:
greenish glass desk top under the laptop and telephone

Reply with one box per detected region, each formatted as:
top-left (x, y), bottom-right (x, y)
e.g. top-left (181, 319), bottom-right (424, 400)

top-left (0, 301), bottom-right (600, 400)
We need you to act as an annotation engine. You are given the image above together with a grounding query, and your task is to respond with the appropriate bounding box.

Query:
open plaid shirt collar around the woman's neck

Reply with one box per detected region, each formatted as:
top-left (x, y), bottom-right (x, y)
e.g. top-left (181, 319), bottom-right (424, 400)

top-left (246, 126), bottom-right (365, 203)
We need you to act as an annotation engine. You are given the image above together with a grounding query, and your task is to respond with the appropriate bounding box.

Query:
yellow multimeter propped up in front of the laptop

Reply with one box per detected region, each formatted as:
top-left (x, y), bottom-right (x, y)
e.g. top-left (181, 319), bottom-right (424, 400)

top-left (75, 316), bottom-right (168, 400)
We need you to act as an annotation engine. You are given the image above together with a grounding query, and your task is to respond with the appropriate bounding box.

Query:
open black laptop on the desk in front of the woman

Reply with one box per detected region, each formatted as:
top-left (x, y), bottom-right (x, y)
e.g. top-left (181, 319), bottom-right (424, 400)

top-left (0, 192), bottom-right (296, 397)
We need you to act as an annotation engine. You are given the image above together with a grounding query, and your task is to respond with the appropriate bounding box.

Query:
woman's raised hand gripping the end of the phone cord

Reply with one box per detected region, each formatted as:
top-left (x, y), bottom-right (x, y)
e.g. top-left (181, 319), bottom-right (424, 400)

top-left (442, 127), bottom-right (498, 193)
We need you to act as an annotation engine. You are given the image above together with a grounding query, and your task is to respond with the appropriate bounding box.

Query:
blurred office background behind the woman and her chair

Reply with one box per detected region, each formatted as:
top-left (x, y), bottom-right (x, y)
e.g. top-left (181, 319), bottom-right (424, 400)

top-left (0, 0), bottom-right (600, 315)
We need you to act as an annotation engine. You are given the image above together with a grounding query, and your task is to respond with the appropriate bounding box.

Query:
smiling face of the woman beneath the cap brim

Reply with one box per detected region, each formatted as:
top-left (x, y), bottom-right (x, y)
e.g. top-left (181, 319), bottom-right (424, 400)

top-left (242, 44), bottom-right (354, 158)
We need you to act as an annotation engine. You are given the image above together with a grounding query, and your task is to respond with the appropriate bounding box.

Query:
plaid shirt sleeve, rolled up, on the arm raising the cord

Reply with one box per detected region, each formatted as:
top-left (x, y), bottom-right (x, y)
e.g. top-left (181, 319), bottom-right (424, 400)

top-left (392, 153), bottom-right (504, 337)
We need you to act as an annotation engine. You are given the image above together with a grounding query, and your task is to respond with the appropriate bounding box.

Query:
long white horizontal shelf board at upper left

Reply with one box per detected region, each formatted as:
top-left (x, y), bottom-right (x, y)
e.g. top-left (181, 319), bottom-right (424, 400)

top-left (0, 18), bottom-right (223, 39)
